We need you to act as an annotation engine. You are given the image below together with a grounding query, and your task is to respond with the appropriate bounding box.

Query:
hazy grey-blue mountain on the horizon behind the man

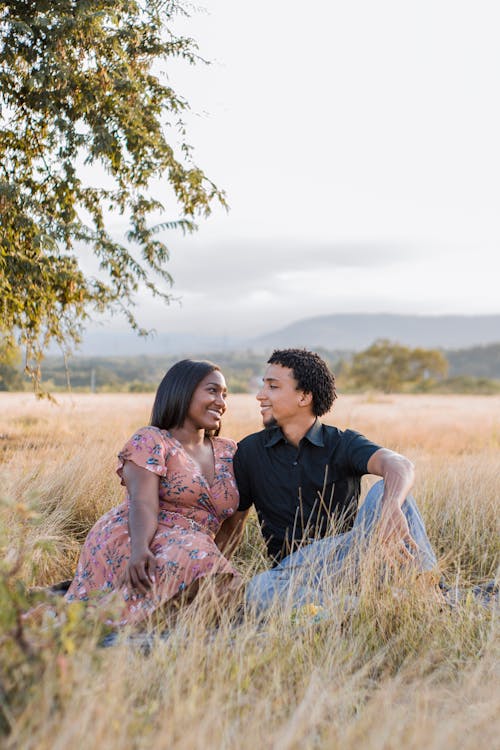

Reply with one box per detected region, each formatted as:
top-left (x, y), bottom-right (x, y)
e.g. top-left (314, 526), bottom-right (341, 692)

top-left (249, 313), bottom-right (500, 351)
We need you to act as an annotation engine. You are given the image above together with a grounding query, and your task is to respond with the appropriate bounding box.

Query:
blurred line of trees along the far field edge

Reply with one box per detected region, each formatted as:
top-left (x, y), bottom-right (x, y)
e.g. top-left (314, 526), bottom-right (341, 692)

top-left (0, 339), bottom-right (500, 393)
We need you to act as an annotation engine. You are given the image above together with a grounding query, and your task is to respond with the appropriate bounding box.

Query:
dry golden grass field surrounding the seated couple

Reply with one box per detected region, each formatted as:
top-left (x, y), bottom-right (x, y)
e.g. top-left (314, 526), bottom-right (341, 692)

top-left (0, 393), bottom-right (500, 750)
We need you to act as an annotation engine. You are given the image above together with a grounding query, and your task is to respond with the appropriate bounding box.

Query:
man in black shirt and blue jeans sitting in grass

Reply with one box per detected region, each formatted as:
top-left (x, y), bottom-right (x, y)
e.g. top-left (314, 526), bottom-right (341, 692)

top-left (229, 349), bottom-right (436, 609)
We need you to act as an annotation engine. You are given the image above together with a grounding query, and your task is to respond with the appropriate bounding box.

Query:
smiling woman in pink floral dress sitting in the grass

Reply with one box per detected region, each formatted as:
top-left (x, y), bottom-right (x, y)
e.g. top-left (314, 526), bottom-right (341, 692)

top-left (66, 360), bottom-right (245, 624)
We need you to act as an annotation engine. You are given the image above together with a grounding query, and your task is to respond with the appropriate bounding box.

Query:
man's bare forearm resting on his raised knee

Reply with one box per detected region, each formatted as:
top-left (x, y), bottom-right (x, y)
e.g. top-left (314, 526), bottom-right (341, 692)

top-left (367, 448), bottom-right (415, 557)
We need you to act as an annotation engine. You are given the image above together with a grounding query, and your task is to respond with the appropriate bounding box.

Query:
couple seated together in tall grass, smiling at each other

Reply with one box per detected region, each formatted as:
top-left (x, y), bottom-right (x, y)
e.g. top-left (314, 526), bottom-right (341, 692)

top-left (66, 349), bottom-right (436, 624)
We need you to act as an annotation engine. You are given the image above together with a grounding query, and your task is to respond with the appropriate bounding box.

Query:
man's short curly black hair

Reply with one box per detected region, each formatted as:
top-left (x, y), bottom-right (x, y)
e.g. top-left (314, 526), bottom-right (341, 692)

top-left (267, 349), bottom-right (337, 417)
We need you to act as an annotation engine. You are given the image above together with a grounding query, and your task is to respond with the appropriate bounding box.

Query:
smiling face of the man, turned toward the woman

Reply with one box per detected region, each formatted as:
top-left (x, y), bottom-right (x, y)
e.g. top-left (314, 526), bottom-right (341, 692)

top-left (257, 365), bottom-right (304, 427)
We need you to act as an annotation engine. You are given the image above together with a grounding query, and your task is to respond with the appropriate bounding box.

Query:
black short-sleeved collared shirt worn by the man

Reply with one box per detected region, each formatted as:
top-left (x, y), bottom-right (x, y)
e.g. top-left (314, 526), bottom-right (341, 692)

top-left (234, 419), bottom-right (380, 561)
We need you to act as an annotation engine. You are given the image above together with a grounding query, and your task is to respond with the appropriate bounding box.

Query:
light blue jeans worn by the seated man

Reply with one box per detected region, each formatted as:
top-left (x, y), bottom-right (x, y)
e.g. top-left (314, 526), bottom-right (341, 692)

top-left (245, 480), bottom-right (437, 613)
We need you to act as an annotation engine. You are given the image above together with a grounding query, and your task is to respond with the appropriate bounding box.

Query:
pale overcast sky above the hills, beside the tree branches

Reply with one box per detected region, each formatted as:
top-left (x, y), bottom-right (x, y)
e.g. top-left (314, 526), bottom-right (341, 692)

top-left (87, 0), bottom-right (500, 335)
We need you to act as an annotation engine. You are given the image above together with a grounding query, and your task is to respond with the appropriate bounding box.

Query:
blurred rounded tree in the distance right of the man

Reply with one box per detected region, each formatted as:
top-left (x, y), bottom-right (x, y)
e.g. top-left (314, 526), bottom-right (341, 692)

top-left (346, 339), bottom-right (448, 393)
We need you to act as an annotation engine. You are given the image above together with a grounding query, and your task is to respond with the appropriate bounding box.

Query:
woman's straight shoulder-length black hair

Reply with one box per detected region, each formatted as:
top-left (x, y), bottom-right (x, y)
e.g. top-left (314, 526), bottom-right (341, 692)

top-left (150, 359), bottom-right (219, 435)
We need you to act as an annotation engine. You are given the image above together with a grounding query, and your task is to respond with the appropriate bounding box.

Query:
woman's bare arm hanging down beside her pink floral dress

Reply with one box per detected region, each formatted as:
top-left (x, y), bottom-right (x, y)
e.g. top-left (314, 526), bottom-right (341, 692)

top-left (122, 461), bottom-right (160, 594)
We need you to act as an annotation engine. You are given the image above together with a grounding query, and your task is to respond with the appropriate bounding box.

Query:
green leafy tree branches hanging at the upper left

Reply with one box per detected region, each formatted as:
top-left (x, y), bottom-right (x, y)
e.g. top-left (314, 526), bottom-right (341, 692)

top-left (0, 0), bottom-right (225, 388)
